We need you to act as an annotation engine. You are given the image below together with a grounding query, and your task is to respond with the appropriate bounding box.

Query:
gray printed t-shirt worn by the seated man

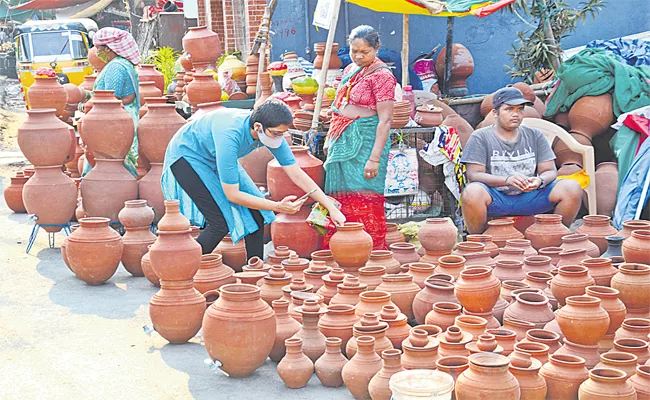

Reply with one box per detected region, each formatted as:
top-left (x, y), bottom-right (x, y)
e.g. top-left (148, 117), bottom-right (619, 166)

top-left (461, 125), bottom-right (555, 195)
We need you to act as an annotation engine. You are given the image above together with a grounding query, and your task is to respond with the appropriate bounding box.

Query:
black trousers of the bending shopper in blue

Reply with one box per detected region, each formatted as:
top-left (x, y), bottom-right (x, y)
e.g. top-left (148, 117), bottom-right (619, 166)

top-left (171, 158), bottom-right (264, 259)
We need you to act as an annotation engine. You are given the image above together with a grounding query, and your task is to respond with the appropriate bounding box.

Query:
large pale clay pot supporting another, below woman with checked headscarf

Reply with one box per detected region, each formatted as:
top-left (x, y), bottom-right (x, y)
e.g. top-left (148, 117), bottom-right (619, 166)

top-left (80, 158), bottom-right (138, 221)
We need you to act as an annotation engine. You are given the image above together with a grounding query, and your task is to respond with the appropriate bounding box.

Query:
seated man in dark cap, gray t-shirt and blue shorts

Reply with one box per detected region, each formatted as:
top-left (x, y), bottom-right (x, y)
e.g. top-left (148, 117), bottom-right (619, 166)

top-left (461, 87), bottom-right (582, 234)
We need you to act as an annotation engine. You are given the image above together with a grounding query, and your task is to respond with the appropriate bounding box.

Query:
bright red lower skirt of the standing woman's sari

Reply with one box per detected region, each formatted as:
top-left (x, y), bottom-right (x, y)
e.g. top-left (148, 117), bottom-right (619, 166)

top-left (325, 192), bottom-right (388, 250)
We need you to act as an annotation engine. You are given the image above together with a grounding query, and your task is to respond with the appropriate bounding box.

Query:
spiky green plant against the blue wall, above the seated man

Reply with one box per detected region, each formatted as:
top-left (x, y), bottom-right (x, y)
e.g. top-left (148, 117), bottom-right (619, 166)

top-left (506, 0), bottom-right (606, 83)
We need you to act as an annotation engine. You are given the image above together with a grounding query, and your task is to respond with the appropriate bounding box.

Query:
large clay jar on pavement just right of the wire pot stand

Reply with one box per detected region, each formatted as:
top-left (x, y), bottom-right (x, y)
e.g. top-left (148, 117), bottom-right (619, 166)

top-left (67, 217), bottom-right (123, 285)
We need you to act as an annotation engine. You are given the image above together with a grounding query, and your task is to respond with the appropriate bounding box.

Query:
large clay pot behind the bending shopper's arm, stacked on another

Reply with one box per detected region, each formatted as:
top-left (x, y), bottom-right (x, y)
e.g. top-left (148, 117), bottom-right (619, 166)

top-left (266, 146), bottom-right (325, 205)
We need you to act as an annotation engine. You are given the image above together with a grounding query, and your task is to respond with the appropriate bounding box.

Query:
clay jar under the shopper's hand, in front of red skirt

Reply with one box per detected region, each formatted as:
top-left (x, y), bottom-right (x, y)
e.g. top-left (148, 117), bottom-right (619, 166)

top-left (330, 222), bottom-right (372, 273)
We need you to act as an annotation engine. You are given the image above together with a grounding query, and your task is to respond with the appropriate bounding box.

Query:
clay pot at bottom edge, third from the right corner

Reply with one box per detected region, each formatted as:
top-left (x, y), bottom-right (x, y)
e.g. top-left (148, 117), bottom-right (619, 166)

top-left (539, 354), bottom-right (589, 399)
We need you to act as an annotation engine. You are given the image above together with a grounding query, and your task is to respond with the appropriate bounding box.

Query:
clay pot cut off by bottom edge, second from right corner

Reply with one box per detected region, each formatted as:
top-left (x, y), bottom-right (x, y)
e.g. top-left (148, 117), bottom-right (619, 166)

top-left (574, 368), bottom-right (637, 400)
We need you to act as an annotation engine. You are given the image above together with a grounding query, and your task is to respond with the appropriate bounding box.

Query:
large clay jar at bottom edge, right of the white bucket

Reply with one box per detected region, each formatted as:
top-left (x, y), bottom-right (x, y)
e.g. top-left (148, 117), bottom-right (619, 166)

top-left (455, 353), bottom-right (520, 400)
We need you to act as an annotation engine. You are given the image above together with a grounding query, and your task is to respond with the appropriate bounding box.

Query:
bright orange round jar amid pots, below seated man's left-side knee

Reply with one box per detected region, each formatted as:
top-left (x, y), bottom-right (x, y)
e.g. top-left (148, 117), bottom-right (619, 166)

top-left (454, 267), bottom-right (501, 313)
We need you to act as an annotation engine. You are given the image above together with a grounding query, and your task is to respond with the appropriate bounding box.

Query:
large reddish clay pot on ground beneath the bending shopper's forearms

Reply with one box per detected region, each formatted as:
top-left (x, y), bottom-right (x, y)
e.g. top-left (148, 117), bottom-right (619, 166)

top-left (271, 206), bottom-right (321, 258)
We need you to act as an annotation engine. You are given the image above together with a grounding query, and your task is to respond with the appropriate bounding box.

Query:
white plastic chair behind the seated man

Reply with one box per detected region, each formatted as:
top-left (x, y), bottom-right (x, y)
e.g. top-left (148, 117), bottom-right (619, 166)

top-left (522, 118), bottom-right (597, 215)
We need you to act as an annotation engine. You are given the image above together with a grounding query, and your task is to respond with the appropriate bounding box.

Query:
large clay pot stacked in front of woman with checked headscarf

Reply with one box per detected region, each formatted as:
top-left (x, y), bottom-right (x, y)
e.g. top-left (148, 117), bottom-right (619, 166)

top-left (80, 100), bottom-right (134, 159)
